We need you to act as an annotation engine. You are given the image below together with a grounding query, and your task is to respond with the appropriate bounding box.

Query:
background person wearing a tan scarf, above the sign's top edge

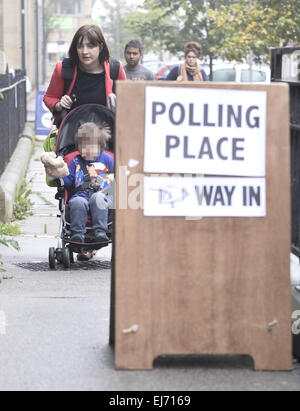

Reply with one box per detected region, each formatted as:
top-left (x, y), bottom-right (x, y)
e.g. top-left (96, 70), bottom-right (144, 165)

top-left (166, 41), bottom-right (209, 81)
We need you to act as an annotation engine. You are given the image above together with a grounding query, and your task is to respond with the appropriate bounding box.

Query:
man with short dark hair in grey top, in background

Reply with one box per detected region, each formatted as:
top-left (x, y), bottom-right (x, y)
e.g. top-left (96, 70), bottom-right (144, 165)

top-left (124, 40), bottom-right (155, 81)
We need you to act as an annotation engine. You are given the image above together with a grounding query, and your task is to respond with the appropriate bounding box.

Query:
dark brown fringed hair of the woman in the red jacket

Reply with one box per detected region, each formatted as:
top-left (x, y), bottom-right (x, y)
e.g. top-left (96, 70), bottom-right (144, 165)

top-left (69, 24), bottom-right (110, 65)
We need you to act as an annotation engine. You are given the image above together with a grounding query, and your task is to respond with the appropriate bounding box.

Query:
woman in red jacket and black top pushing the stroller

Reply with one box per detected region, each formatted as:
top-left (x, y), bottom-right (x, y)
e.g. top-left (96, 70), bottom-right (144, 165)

top-left (44, 24), bottom-right (126, 126)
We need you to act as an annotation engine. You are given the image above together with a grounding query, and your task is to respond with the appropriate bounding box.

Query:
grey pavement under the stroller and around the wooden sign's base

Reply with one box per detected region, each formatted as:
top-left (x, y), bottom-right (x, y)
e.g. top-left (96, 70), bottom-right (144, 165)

top-left (0, 96), bottom-right (300, 391)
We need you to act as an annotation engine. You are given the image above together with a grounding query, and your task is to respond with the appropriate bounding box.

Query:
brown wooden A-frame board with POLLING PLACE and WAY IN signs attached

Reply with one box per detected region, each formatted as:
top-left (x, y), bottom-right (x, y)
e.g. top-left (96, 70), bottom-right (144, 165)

top-left (110, 82), bottom-right (292, 370)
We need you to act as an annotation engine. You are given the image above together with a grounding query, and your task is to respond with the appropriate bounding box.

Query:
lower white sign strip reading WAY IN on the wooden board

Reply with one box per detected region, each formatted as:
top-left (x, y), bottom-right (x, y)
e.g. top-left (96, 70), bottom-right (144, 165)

top-left (144, 177), bottom-right (266, 217)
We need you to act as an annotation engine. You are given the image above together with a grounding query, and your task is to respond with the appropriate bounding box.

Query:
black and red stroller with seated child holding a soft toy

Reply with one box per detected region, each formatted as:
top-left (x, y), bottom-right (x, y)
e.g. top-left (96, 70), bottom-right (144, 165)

top-left (42, 105), bottom-right (114, 269)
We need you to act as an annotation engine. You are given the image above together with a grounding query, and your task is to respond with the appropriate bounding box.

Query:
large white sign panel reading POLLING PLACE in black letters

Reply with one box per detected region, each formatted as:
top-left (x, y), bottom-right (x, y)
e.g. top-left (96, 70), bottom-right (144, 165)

top-left (144, 86), bottom-right (267, 177)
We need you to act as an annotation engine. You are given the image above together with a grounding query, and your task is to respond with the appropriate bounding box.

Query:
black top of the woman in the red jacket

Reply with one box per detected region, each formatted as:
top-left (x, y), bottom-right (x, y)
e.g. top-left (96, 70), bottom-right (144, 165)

top-left (72, 68), bottom-right (106, 109)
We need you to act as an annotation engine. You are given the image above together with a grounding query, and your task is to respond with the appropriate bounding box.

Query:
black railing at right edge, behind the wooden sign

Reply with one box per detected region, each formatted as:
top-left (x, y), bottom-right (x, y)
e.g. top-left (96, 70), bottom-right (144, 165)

top-left (271, 47), bottom-right (300, 257)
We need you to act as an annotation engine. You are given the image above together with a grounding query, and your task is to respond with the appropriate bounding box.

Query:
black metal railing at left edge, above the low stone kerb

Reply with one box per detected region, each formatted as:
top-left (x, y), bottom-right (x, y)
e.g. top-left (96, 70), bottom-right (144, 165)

top-left (0, 70), bottom-right (26, 175)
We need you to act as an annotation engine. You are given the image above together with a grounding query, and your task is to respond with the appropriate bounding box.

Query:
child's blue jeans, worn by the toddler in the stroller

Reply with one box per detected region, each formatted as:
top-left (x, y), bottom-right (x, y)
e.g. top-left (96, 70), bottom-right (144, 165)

top-left (69, 191), bottom-right (112, 238)
